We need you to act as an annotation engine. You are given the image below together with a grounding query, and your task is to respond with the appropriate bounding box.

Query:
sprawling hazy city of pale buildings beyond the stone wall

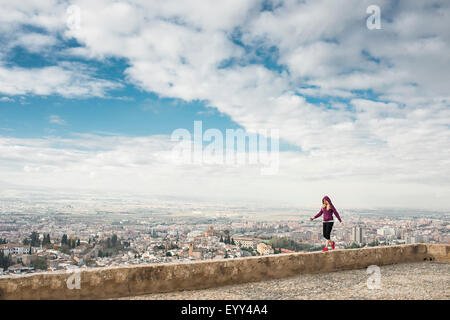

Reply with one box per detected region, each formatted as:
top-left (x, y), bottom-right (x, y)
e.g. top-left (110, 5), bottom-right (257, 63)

top-left (0, 197), bottom-right (450, 276)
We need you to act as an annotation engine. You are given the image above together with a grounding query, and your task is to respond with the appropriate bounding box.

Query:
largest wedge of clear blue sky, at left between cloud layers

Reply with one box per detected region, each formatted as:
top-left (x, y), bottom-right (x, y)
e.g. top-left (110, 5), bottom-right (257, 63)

top-left (1, 87), bottom-right (239, 138)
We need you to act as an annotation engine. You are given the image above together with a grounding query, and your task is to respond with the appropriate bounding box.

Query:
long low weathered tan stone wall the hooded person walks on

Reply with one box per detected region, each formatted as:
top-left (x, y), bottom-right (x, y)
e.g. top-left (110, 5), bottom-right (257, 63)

top-left (0, 243), bottom-right (450, 299)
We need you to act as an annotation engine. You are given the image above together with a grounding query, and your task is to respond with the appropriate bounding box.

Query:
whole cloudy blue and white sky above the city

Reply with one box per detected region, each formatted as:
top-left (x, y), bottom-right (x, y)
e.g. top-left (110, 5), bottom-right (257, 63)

top-left (0, 0), bottom-right (450, 210)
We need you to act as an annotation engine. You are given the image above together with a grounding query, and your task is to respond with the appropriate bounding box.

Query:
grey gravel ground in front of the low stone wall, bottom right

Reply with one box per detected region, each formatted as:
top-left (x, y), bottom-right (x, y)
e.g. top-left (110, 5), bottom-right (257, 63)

top-left (118, 262), bottom-right (450, 300)
